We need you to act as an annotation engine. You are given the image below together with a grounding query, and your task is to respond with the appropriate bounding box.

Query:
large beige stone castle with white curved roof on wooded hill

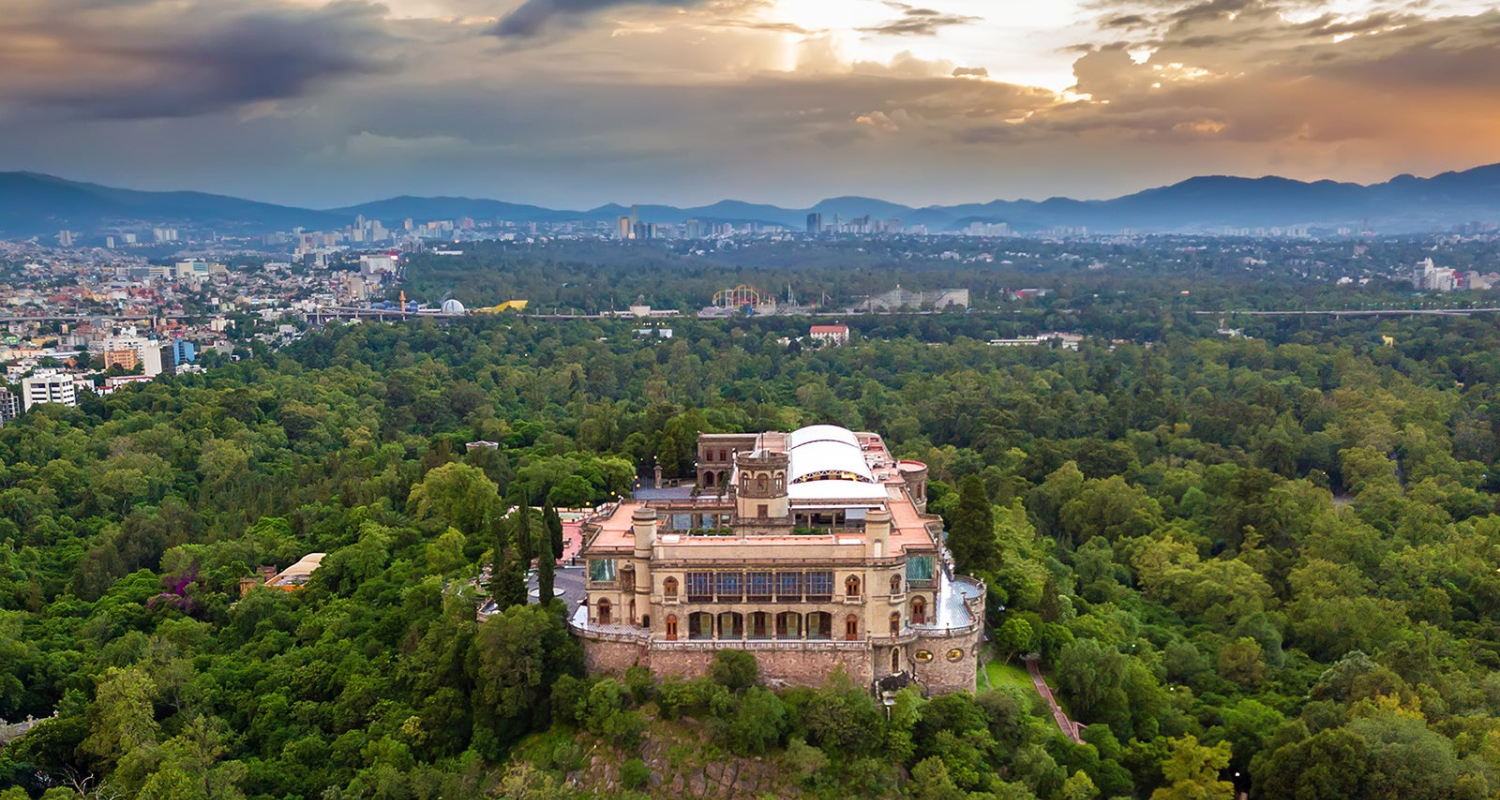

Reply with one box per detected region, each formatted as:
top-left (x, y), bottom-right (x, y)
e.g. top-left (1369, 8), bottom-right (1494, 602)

top-left (570, 425), bottom-right (986, 693)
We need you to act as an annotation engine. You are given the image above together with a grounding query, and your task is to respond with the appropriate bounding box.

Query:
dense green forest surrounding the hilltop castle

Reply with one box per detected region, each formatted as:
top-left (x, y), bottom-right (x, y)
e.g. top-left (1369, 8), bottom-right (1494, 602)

top-left (0, 293), bottom-right (1500, 800)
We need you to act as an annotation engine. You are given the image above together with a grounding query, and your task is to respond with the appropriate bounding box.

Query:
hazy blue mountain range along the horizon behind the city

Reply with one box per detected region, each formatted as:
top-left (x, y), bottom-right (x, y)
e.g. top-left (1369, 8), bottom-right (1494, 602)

top-left (0, 164), bottom-right (1500, 237)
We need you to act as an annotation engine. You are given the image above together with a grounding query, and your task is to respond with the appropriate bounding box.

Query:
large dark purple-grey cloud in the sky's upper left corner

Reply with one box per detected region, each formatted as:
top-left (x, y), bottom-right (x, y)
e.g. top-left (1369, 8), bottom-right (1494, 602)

top-left (0, 0), bottom-right (389, 119)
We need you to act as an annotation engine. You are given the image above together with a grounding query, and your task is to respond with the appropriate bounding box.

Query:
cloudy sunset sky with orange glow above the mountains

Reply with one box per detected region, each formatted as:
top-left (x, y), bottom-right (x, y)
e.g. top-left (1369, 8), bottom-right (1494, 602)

top-left (0, 0), bottom-right (1500, 207)
